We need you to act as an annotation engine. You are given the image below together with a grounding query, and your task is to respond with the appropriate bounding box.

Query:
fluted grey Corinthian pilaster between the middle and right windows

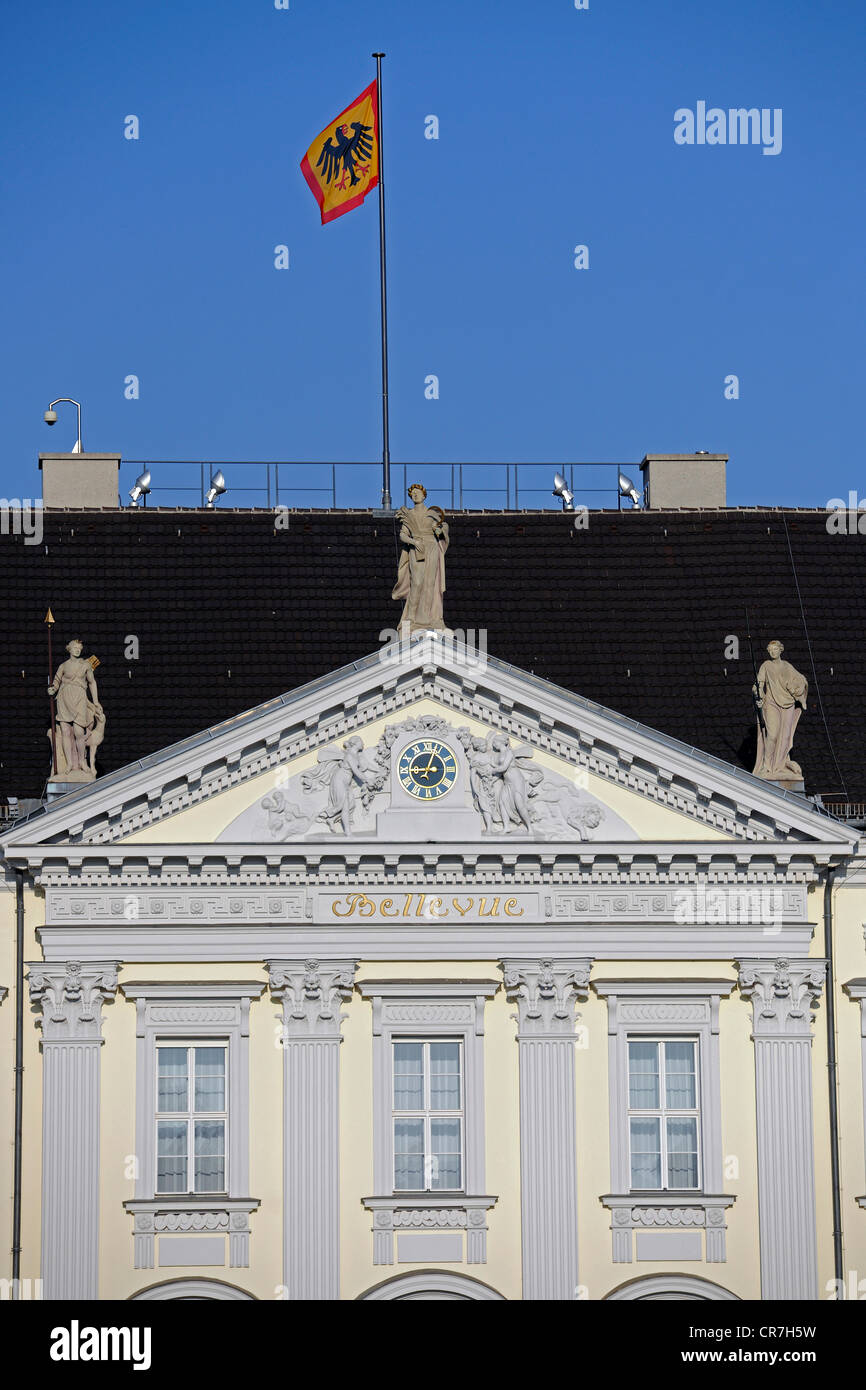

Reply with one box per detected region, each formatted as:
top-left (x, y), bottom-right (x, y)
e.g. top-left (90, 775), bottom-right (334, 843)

top-left (502, 960), bottom-right (592, 1300)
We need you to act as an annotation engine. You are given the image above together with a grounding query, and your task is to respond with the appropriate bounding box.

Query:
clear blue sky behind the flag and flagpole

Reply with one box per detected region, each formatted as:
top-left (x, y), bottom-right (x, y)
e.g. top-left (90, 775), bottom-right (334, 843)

top-left (0, 0), bottom-right (866, 506)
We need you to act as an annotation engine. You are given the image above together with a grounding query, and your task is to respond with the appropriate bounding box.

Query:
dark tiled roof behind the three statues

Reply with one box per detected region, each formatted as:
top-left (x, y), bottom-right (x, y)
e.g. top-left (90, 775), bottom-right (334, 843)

top-left (0, 510), bottom-right (866, 801)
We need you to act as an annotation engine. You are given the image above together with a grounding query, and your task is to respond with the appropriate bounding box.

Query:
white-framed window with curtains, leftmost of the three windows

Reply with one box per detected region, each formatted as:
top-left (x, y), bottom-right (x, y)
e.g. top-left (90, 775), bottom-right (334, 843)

top-left (156, 1043), bottom-right (228, 1195)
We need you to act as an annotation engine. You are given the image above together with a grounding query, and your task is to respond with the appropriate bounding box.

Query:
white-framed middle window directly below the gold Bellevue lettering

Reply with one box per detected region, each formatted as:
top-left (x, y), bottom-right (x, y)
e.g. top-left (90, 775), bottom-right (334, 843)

top-left (392, 1041), bottom-right (463, 1193)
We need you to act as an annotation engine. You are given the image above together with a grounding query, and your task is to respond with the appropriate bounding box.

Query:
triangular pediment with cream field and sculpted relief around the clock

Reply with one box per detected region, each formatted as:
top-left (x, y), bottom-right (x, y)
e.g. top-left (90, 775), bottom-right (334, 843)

top-left (4, 635), bottom-right (858, 851)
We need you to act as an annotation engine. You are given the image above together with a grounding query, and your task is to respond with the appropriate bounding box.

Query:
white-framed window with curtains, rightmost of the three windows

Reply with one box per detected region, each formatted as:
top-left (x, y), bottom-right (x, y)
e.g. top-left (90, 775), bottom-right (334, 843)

top-left (628, 1038), bottom-right (701, 1191)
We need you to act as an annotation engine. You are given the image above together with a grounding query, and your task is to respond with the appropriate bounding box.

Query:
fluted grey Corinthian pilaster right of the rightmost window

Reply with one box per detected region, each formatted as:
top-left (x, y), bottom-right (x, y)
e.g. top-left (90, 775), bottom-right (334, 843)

top-left (740, 959), bottom-right (827, 1300)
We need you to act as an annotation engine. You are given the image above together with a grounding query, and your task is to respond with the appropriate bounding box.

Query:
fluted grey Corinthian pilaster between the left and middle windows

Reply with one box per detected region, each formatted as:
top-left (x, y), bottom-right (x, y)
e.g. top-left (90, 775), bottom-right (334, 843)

top-left (268, 960), bottom-right (356, 1301)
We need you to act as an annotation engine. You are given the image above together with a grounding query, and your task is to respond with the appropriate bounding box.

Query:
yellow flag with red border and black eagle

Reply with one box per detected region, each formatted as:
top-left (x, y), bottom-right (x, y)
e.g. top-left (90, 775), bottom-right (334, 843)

top-left (300, 81), bottom-right (379, 224)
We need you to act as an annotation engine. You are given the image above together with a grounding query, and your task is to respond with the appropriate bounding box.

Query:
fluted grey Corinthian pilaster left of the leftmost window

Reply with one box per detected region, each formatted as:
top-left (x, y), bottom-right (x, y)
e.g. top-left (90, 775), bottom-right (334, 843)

top-left (28, 960), bottom-right (118, 1298)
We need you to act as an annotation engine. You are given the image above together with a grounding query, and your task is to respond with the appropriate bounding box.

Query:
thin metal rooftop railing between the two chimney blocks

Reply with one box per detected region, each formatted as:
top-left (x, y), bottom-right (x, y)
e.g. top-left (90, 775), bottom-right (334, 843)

top-left (120, 459), bottom-right (642, 512)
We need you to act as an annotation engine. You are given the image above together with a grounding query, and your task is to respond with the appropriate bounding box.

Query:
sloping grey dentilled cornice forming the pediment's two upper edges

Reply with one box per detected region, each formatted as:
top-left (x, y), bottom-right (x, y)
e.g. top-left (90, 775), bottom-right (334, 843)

top-left (6, 638), bottom-right (859, 852)
